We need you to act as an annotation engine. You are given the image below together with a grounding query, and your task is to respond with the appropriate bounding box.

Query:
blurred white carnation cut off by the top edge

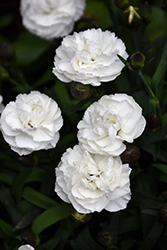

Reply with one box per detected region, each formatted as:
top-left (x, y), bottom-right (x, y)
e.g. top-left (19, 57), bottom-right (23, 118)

top-left (20, 0), bottom-right (85, 39)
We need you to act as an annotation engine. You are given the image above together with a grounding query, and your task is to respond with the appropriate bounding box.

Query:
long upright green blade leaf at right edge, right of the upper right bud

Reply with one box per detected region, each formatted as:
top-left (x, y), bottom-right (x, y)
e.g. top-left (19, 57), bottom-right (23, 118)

top-left (151, 43), bottom-right (167, 90)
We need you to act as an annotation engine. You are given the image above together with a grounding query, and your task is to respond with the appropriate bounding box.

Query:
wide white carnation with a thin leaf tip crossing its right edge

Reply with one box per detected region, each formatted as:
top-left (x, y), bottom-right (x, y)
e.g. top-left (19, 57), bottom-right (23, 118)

top-left (53, 29), bottom-right (128, 86)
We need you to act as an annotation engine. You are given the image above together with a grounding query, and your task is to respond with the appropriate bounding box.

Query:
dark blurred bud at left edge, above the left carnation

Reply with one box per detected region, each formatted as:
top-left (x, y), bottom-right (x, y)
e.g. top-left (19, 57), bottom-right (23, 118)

top-left (0, 43), bottom-right (15, 66)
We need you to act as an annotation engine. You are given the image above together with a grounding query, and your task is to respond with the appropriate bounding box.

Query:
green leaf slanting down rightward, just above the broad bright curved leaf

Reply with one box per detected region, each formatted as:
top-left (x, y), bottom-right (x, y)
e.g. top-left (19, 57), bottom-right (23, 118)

top-left (22, 187), bottom-right (59, 209)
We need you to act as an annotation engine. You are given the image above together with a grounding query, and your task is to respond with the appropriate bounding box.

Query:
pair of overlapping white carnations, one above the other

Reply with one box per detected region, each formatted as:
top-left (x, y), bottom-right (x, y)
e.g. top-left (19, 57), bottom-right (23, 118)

top-left (55, 94), bottom-right (146, 214)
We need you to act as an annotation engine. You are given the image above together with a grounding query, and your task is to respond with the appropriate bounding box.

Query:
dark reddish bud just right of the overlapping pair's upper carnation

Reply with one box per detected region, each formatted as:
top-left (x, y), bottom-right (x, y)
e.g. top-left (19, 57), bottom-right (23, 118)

top-left (146, 112), bottom-right (160, 131)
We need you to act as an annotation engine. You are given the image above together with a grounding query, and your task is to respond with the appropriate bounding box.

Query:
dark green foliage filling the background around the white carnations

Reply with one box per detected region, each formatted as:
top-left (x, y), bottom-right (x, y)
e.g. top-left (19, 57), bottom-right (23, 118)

top-left (0, 0), bottom-right (167, 250)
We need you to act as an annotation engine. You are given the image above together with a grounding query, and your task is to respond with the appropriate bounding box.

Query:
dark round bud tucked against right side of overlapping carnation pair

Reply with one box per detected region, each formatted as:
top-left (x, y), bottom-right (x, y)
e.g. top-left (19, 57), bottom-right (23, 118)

top-left (121, 144), bottom-right (140, 164)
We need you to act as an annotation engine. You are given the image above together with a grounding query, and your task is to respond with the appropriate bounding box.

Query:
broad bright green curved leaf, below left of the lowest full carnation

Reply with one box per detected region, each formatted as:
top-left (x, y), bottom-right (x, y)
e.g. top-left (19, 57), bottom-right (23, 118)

top-left (31, 204), bottom-right (71, 234)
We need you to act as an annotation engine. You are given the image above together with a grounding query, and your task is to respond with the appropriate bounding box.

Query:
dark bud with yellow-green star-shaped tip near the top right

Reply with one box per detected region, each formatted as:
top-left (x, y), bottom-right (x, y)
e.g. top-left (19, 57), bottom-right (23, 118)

top-left (122, 6), bottom-right (142, 28)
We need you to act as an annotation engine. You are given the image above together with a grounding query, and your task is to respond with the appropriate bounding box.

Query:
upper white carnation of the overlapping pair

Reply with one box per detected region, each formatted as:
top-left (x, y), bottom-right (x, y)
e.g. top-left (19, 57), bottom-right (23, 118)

top-left (78, 94), bottom-right (146, 156)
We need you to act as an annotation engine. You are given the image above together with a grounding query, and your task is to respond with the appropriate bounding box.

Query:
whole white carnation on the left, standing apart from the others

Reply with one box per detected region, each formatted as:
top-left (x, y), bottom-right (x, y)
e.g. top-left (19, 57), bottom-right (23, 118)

top-left (1, 91), bottom-right (63, 155)
